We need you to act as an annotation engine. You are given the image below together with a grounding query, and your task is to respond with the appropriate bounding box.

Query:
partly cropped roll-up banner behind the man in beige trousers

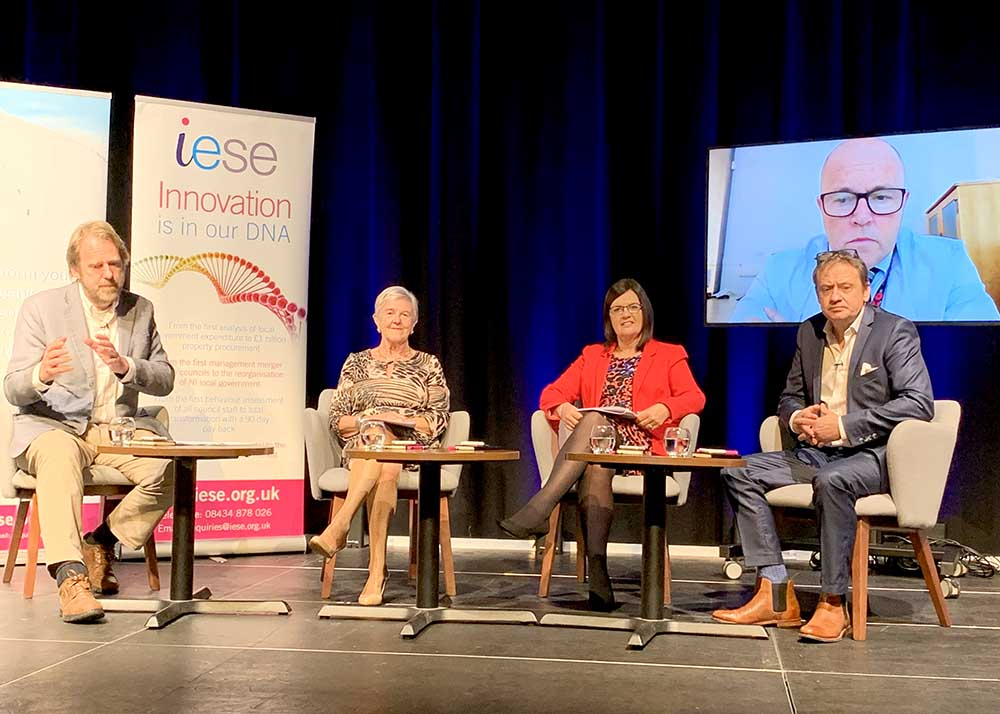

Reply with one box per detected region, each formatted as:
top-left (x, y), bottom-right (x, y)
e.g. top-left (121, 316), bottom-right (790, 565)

top-left (0, 82), bottom-right (111, 550)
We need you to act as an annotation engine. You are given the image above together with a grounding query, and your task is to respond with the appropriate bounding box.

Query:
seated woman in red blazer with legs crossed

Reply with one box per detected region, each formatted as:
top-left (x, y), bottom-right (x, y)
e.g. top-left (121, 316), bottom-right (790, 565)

top-left (498, 278), bottom-right (705, 611)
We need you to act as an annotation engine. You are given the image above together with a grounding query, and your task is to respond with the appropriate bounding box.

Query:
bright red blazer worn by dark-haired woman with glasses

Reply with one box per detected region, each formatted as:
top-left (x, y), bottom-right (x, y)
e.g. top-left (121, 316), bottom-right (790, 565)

top-left (538, 340), bottom-right (705, 454)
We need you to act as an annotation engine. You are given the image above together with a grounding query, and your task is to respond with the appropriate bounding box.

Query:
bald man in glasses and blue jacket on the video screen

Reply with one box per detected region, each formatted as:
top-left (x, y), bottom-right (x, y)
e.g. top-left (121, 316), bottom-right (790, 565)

top-left (731, 139), bottom-right (1000, 322)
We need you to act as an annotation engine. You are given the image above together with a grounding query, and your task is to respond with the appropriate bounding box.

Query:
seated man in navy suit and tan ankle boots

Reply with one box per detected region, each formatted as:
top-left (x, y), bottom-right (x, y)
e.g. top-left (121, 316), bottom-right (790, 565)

top-left (712, 250), bottom-right (934, 642)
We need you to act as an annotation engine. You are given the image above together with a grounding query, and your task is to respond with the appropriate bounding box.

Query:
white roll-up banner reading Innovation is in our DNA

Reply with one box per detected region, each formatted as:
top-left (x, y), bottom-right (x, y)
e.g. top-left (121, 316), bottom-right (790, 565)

top-left (130, 97), bottom-right (315, 554)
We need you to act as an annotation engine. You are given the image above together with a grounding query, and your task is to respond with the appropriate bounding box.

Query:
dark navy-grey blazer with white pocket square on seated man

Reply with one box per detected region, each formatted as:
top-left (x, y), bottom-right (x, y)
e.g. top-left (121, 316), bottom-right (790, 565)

top-left (778, 305), bottom-right (934, 471)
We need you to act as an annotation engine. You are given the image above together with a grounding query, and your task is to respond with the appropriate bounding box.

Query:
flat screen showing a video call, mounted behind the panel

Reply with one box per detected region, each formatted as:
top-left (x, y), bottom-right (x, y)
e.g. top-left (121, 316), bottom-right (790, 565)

top-left (705, 128), bottom-right (1000, 325)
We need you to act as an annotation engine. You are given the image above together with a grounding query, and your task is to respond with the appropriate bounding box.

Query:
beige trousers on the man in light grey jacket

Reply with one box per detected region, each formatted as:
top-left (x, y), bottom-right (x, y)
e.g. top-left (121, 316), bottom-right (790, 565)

top-left (17, 426), bottom-right (173, 564)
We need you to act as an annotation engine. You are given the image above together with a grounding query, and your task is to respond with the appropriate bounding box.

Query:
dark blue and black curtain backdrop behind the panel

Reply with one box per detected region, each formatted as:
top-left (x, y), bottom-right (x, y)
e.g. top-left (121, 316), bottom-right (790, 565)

top-left (0, 0), bottom-right (1000, 552)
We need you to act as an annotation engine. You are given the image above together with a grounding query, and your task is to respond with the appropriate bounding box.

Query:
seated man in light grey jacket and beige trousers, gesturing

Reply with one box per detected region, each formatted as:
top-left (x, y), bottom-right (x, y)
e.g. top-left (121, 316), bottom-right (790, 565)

top-left (4, 221), bottom-right (174, 622)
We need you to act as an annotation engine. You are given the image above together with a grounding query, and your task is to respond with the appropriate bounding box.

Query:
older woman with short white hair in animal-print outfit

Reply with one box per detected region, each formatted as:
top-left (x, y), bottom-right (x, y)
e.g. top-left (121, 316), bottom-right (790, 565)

top-left (309, 286), bottom-right (449, 605)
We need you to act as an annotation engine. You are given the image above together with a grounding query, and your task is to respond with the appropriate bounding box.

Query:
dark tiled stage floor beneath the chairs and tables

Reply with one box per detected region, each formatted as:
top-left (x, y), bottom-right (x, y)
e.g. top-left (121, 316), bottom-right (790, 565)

top-left (0, 549), bottom-right (1000, 714)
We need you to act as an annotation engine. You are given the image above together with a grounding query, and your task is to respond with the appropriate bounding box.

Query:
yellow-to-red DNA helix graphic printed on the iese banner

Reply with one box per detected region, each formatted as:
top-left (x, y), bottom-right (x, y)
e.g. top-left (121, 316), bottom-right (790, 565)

top-left (132, 253), bottom-right (306, 337)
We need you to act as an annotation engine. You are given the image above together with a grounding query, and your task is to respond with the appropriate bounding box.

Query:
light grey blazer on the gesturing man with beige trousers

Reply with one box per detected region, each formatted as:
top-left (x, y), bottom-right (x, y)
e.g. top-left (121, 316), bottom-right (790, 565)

top-left (3, 282), bottom-right (174, 457)
